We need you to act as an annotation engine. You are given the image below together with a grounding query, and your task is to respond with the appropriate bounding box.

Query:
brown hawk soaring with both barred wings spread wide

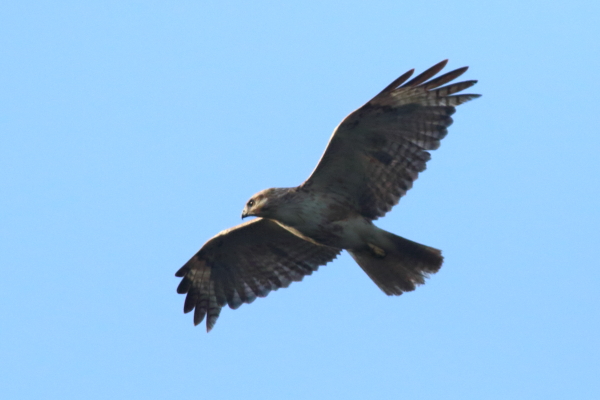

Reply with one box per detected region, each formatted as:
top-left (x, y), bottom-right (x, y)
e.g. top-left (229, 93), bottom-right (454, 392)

top-left (175, 60), bottom-right (479, 331)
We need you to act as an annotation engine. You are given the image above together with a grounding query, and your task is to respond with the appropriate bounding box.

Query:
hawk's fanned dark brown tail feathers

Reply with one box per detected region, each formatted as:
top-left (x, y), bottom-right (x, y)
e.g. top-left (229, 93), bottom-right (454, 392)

top-left (348, 230), bottom-right (444, 296)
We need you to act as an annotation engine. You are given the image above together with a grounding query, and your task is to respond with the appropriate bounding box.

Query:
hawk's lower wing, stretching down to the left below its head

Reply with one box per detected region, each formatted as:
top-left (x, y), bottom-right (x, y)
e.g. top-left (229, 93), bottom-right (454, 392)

top-left (175, 218), bottom-right (341, 331)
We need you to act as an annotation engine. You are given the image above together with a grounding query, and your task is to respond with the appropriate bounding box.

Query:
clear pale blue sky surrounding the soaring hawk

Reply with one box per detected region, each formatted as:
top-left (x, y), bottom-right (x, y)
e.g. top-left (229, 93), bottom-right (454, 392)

top-left (0, 0), bottom-right (600, 400)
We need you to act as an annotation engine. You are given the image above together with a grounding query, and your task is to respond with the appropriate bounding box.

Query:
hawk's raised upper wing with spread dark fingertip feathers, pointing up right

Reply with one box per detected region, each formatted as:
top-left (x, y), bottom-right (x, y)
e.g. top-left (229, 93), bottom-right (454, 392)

top-left (304, 61), bottom-right (479, 219)
